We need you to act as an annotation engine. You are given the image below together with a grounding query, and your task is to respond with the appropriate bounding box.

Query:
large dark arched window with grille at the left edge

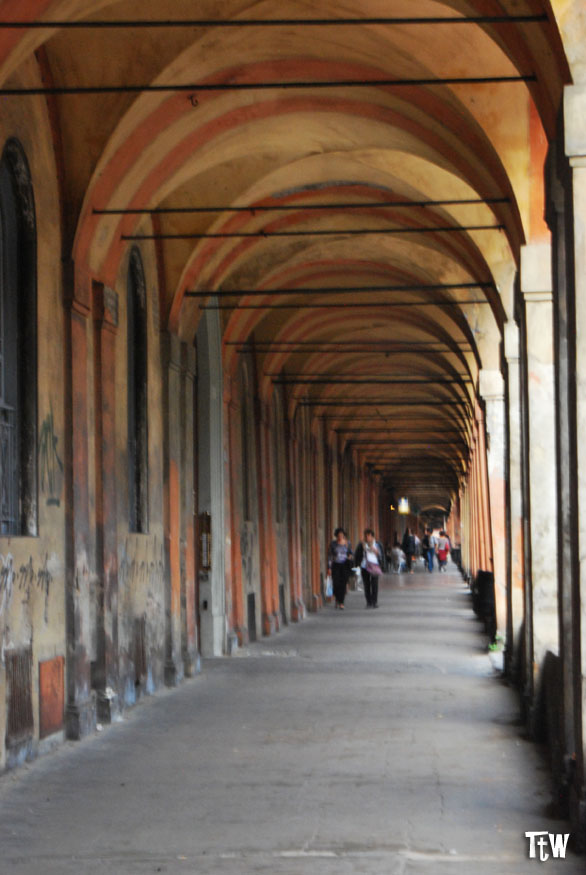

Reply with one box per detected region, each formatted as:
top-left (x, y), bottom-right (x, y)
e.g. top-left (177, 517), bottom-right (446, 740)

top-left (0, 140), bottom-right (38, 535)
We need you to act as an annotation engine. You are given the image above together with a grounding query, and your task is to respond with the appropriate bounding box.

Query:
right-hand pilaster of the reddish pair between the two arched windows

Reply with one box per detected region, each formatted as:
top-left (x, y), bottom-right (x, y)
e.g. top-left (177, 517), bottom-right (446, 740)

top-left (93, 283), bottom-right (120, 723)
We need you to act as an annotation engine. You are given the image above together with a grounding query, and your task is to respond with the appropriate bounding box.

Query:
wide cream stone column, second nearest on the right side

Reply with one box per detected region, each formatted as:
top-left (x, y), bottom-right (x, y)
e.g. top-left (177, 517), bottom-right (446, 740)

top-left (521, 243), bottom-right (559, 680)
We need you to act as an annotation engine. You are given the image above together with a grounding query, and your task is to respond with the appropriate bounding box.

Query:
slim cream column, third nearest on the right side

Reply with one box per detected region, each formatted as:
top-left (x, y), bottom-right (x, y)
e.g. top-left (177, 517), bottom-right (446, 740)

top-left (505, 322), bottom-right (525, 676)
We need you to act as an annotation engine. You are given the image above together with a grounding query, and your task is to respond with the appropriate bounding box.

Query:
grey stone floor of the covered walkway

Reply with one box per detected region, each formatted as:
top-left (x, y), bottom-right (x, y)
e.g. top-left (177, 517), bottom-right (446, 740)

top-left (0, 567), bottom-right (585, 875)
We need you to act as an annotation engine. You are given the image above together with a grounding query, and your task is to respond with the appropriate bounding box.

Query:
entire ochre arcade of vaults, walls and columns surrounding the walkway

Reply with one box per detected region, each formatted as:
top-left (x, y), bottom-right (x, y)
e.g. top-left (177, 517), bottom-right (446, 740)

top-left (0, 0), bottom-right (586, 852)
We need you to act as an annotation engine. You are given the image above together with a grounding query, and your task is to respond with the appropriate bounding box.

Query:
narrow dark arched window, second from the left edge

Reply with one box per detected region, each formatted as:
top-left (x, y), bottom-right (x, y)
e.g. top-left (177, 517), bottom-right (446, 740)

top-left (126, 249), bottom-right (148, 532)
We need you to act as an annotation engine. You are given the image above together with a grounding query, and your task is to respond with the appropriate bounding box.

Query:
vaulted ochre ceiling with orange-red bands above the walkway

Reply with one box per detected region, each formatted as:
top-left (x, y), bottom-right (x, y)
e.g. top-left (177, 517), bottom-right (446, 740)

top-left (0, 0), bottom-right (569, 512)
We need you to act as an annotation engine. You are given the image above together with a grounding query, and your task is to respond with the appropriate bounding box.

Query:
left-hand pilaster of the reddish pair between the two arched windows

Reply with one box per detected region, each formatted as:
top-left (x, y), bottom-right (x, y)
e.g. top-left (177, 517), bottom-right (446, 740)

top-left (64, 262), bottom-right (96, 739)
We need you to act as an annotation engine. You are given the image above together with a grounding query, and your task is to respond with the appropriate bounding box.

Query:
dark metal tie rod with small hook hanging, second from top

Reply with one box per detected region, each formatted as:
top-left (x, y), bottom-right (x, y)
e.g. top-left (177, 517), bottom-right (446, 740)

top-left (0, 73), bottom-right (537, 97)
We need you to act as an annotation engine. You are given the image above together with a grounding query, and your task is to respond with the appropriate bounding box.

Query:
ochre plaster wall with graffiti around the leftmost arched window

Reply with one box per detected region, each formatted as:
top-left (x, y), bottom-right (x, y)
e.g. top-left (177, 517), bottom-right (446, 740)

top-left (0, 53), bottom-right (65, 768)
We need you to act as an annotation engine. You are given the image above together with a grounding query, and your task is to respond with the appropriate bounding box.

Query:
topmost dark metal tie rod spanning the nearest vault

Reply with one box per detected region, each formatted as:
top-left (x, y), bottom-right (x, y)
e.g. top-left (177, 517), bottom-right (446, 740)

top-left (0, 13), bottom-right (548, 30)
